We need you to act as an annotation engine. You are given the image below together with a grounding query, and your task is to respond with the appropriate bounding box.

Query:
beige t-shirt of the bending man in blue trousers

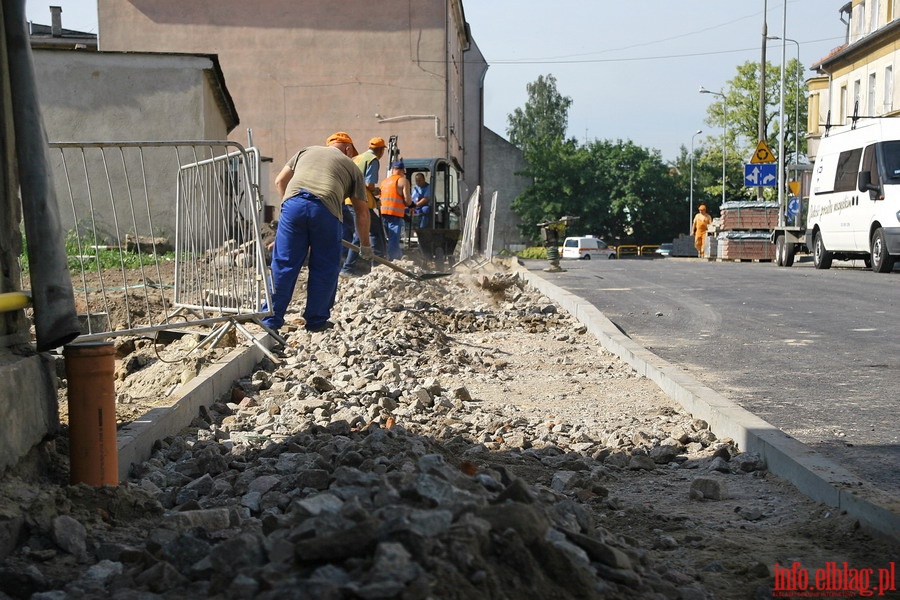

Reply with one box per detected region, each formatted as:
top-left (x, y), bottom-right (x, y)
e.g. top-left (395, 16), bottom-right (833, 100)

top-left (282, 146), bottom-right (366, 221)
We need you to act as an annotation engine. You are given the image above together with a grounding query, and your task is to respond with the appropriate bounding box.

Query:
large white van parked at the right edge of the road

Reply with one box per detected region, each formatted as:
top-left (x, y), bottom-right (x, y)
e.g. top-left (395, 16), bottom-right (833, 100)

top-left (806, 118), bottom-right (900, 273)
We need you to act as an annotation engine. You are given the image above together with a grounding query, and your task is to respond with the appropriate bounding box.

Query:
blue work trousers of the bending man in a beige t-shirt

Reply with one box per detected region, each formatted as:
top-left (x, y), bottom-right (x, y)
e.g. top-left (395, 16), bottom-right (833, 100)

top-left (263, 190), bottom-right (342, 330)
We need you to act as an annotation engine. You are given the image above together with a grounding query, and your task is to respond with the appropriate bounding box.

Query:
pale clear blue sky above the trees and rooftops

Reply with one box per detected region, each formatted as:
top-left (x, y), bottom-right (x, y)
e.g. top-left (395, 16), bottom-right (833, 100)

top-left (26, 0), bottom-right (846, 160)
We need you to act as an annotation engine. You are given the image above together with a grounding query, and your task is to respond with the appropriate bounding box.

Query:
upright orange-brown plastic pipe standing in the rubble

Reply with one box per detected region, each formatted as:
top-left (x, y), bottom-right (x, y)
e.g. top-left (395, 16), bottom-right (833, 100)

top-left (63, 342), bottom-right (119, 486)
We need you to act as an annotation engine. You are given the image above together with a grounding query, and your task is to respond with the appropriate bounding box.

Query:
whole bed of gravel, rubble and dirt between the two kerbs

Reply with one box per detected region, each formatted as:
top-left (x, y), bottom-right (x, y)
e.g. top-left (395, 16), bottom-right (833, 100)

top-left (0, 268), bottom-right (897, 600)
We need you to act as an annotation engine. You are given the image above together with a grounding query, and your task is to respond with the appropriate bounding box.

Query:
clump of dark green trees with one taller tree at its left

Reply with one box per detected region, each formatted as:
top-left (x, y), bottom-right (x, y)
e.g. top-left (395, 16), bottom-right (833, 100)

top-left (507, 75), bottom-right (687, 243)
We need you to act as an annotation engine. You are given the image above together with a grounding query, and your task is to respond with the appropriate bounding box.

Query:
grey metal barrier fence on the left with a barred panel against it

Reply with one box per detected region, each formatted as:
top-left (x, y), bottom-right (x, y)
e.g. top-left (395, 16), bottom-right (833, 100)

top-left (38, 141), bottom-right (269, 356)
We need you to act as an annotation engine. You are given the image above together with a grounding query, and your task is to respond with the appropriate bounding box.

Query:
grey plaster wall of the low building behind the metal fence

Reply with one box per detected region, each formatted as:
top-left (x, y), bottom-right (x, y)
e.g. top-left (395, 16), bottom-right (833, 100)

top-left (33, 49), bottom-right (238, 243)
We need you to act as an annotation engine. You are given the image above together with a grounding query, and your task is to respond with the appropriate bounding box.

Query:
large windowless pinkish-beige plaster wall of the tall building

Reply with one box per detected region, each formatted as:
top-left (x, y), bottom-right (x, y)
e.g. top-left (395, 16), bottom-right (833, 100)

top-left (98, 0), bottom-right (480, 209)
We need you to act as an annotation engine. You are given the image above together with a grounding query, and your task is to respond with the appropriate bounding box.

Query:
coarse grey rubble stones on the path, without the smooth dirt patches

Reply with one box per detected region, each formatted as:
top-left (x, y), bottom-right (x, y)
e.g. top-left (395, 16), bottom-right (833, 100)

top-left (0, 270), bottom-right (780, 600)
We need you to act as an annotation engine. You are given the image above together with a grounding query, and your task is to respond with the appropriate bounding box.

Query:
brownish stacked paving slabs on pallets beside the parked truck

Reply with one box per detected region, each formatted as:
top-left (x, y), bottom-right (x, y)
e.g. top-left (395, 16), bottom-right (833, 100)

top-left (715, 201), bottom-right (778, 261)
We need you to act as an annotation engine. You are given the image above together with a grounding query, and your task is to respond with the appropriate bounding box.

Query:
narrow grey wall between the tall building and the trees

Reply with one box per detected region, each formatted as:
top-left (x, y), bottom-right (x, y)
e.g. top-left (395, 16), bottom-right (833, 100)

top-left (483, 127), bottom-right (531, 250)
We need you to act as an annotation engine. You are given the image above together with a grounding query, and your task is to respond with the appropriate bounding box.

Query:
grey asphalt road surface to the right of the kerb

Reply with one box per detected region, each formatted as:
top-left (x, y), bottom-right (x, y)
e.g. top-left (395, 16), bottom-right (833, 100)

top-left (526, 257), bottom-right (900, 497)
